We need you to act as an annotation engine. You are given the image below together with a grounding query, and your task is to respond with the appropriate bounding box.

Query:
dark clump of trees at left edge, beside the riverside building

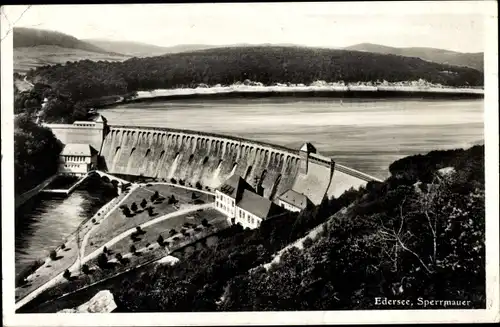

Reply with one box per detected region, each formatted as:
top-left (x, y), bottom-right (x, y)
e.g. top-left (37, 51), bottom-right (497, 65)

top-left (14, 114), bottom-right (62, 194)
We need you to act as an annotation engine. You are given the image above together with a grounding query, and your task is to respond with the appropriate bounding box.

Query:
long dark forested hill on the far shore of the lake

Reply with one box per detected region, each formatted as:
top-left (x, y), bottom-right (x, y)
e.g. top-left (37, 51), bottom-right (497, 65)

top-left (27, 46), bottom-right (484, 101)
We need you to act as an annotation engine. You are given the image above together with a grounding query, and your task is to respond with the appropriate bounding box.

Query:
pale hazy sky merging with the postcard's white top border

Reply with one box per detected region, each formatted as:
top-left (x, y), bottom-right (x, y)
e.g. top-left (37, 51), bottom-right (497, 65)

top-left (3, 1), bottom-right (495, 52)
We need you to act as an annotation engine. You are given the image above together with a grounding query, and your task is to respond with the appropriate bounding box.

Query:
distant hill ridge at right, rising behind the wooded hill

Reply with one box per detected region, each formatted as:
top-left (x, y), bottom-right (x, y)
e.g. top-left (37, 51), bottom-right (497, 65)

top-left (345, 43), bottom-right (484, 71)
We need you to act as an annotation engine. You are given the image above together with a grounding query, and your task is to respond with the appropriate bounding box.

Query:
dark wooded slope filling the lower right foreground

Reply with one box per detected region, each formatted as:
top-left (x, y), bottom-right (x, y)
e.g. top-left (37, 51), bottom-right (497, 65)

top-left (113, 146), bottom-right (485, 312)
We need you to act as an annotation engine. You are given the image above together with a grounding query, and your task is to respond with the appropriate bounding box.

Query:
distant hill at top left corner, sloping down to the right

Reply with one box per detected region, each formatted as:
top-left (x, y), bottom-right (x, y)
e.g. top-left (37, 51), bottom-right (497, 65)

top-left (13, 27), bottom-right (120, 55)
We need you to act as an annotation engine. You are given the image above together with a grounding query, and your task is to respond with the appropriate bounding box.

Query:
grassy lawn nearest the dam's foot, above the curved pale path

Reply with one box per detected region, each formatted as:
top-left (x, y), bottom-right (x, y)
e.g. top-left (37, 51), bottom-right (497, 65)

top-left (85, 185), bottom-right (213, 255)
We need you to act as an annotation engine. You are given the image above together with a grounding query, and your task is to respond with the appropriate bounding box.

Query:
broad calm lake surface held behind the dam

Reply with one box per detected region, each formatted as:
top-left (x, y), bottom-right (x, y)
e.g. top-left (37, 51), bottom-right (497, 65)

top-left (101, 98), bottom-right (484, 178)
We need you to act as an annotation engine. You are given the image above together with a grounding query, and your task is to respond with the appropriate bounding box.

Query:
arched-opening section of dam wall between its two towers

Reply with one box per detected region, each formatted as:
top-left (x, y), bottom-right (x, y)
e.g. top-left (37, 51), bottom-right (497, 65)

top-left (101, 126), bottom-right (300, 199)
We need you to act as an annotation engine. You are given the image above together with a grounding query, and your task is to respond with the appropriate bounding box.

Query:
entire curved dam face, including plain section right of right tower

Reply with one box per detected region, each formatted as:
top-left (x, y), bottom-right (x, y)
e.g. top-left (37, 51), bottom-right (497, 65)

top-left (101, 126), bottom-right (374, 204)
